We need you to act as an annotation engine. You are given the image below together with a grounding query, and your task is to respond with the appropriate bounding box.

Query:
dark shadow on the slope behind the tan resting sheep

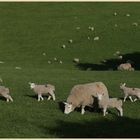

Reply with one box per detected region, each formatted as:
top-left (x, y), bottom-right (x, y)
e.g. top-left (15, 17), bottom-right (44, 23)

top-left (76, 52), bottom-right (140, 71)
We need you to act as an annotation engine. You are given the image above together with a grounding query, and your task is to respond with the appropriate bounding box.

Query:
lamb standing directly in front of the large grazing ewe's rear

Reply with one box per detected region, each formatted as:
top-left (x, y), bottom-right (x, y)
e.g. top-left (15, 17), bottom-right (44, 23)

top-left (97, 93), bottom-right (123, 116)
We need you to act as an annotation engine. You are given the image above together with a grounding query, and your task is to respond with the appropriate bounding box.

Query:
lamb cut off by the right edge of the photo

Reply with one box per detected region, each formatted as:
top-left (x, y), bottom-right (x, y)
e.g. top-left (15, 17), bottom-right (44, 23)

top-left (120, 83), bottom-right (140, 102)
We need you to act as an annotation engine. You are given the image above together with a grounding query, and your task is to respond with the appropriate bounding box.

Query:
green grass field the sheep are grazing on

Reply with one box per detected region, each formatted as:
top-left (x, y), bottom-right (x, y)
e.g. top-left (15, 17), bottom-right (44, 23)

top-left (0, 2), bottom-right (140, 138)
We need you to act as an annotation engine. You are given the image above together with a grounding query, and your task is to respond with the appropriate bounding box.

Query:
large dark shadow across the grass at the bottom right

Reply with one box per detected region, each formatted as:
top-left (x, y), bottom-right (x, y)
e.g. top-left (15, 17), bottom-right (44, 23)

top-left (41, 116), bottom-right (140, 138)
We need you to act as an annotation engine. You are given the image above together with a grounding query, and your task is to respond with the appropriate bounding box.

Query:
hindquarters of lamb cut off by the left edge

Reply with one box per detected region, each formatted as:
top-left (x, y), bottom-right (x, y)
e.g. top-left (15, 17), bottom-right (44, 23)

top-left (0, 86), bottom-right (13, 102)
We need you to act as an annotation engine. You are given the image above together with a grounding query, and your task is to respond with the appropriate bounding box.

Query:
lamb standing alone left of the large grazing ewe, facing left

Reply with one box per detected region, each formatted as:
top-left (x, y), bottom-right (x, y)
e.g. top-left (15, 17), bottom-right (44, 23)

top-left (29, 82), bottom-right (55, 101)
